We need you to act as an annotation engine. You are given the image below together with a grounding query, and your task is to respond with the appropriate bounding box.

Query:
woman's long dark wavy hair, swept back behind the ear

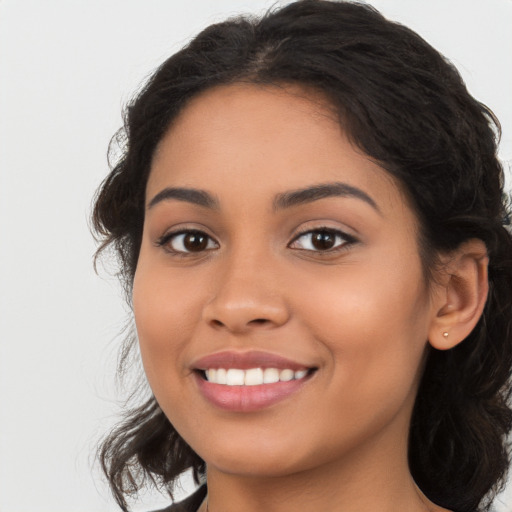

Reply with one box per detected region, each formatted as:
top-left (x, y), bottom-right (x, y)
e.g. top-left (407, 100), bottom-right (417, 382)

top-left (93, 0), bottom-right (512, 512)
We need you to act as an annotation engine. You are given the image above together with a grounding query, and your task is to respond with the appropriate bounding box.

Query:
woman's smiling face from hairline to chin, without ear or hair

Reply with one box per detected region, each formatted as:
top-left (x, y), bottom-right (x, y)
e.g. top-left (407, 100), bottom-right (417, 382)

top-left (133, 84), bottom-right (435, 475)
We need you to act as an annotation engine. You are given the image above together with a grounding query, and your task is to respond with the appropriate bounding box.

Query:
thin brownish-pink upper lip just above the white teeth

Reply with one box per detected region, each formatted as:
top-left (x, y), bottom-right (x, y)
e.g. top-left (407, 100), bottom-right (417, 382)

top-left (191, 350), bottom-right (312, 371)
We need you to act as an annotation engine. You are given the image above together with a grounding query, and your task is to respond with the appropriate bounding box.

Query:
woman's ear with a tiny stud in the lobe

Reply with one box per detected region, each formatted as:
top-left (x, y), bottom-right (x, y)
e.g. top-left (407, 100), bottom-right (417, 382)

top-left (428, 239), bottom-right (489, 350)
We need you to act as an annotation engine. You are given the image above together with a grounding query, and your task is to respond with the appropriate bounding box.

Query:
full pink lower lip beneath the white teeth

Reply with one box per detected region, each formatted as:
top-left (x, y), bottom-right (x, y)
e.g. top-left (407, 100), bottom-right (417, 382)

top-left (196, 375), bottom-right (311, 412)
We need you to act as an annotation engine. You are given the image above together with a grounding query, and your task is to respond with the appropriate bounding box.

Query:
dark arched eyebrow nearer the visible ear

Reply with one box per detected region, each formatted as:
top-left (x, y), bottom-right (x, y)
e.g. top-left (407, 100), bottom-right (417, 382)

top-left (274, 182), bottom-right (381, 214)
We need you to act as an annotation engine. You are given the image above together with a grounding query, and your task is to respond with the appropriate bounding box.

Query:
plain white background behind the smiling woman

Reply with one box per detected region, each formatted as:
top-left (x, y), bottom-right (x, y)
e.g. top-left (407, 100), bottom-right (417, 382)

top-left (0, 0), bottom-right (512, 512)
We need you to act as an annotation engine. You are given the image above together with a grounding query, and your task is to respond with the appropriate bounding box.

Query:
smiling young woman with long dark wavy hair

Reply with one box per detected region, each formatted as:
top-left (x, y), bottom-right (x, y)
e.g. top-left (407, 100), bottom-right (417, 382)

top-left (94, 0), bottom-right (512, 512)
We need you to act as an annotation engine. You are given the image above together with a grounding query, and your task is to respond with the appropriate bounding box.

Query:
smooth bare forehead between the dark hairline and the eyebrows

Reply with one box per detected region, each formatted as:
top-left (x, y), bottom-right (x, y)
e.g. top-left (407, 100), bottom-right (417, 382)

top-left (147, 84), bottom-right (405, 218)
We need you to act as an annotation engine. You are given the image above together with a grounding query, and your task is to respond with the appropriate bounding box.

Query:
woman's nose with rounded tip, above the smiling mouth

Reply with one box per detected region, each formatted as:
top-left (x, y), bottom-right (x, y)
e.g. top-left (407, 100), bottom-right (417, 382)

top-left (203, 254), bottom-right (290, 334)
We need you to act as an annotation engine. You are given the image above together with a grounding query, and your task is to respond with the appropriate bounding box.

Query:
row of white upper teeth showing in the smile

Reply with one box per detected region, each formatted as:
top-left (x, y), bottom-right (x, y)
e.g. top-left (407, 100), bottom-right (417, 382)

top-left (205, 368), bottom-right (308, 386)
